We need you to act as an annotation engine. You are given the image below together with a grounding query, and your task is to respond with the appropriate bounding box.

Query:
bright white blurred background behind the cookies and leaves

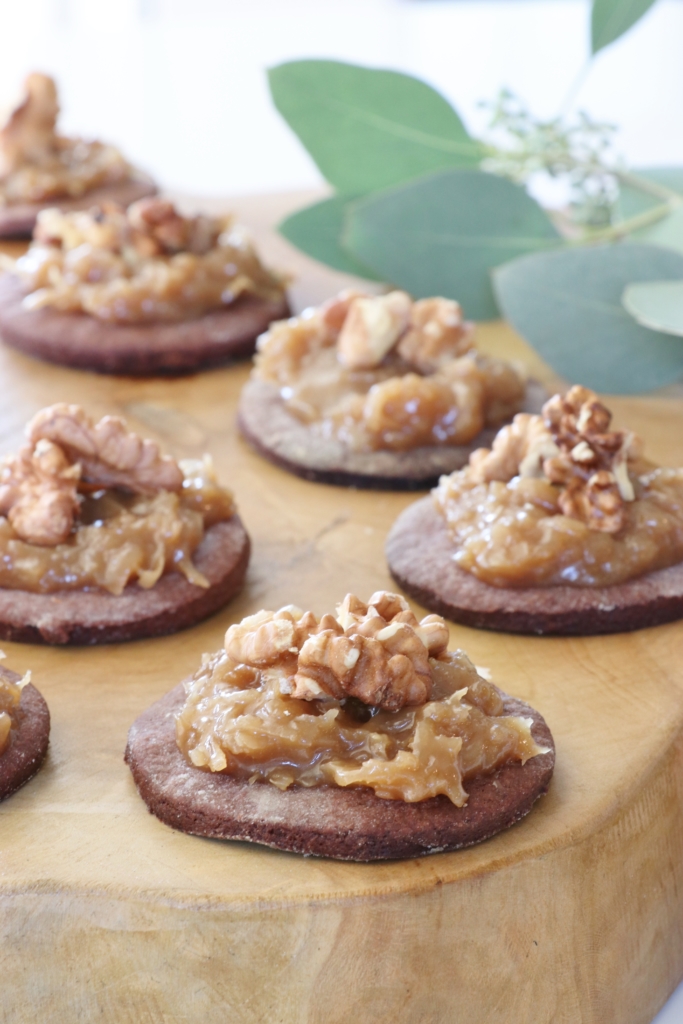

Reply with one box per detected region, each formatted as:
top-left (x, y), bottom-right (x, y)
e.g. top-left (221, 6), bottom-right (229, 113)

top-left (0, 0), bottom-right (683, 196)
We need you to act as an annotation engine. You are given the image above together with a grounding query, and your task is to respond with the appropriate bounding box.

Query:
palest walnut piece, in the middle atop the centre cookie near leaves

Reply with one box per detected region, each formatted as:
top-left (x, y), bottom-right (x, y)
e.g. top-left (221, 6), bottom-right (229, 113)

top-left (337, 292), bottom-right (413, 370)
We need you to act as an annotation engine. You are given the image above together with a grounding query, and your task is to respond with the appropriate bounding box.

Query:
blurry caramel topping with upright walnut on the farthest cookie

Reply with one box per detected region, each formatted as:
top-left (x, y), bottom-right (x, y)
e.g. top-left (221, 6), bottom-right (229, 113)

top-left (0, 74), bottom-right (132, 206)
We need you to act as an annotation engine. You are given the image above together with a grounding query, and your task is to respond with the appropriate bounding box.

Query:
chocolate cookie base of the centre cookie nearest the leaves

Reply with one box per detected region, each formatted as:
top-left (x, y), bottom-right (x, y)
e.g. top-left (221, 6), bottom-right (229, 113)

top-left (238, 379), bottom-right (547, 490)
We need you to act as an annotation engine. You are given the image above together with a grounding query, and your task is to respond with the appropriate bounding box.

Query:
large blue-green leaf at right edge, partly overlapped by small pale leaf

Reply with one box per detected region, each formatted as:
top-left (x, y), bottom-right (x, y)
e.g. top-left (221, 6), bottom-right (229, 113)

top-left (494, 243), bottom-right (683, 394)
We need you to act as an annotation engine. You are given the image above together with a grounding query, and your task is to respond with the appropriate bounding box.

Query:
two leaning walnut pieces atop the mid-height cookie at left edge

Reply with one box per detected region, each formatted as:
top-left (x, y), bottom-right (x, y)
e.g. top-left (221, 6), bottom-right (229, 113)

top-left (0, 402), bottom-right (184, 547)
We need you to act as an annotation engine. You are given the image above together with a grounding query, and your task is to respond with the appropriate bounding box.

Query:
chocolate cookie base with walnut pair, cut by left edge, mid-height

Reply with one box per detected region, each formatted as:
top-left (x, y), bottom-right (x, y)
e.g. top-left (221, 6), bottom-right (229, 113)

top-left (0, 515), bottom-right (251, 644)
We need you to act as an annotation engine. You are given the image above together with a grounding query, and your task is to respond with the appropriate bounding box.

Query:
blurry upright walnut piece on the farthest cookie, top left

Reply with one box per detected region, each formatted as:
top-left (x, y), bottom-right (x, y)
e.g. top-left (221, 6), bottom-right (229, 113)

top-left (0, 74), bottom-right (59, 177)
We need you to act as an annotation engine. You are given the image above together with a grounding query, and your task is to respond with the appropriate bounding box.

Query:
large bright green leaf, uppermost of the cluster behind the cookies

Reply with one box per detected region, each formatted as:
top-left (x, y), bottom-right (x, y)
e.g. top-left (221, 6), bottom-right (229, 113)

top-left (268, 60), bottom-right (483, 196)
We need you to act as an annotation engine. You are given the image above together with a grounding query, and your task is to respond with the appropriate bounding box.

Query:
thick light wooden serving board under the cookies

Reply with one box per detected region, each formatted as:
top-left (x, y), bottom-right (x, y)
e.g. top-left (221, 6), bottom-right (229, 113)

top-left (0, 196), bottom-right (683, 1024)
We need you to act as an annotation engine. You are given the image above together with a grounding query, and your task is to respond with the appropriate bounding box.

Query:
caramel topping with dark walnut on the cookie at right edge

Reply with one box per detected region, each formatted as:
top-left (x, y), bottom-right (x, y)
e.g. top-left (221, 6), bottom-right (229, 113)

top-left (434, 386), bottom-right (683, 587)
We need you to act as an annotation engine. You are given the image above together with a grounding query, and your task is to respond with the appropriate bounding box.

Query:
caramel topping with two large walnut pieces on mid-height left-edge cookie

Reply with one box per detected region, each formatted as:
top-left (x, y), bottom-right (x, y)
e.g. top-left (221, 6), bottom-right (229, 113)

top-left (0, 403), bottom-right (234, 594)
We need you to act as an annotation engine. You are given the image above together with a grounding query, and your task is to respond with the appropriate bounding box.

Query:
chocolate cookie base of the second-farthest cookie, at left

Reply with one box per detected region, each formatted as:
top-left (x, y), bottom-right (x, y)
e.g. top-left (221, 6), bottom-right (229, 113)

top-left (0, 273), bottom-right (289, 377)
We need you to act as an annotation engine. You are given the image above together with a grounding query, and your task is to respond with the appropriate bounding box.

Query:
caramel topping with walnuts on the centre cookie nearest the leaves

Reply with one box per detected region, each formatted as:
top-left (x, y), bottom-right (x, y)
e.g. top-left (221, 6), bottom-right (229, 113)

top-left (254, 291), bottom-right (524, 451)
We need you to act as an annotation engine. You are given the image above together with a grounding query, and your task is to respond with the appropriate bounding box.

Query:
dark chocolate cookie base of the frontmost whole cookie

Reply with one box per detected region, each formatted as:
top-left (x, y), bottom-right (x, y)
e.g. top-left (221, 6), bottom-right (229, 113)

top-left (125, 684), bottom-right (555, 861)
